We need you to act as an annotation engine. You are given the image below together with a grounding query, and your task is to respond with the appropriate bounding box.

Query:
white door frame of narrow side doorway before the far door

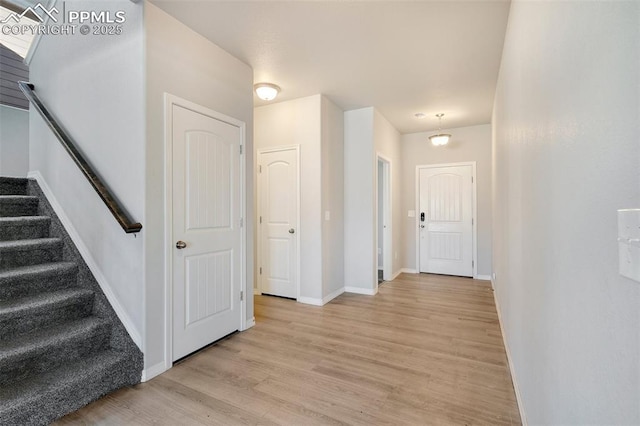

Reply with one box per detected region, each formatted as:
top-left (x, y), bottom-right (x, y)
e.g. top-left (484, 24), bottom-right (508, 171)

top-left (376, 153), bottom-right (393, 282)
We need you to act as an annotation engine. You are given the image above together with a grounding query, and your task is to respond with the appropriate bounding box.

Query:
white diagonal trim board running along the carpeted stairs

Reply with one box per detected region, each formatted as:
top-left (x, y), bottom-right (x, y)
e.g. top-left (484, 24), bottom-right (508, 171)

top-left (27, 170), bottom-right (142, 348)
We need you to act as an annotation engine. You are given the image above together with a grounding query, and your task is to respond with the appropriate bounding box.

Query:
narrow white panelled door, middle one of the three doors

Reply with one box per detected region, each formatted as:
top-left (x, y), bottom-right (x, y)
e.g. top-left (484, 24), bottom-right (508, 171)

top-left (258, 148), bottom-right (299, 299)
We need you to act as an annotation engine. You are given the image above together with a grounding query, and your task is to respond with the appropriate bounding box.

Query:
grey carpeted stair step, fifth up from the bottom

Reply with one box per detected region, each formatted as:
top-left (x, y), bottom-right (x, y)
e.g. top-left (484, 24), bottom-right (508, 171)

top-left (0, 238), bottom-right (62, 271)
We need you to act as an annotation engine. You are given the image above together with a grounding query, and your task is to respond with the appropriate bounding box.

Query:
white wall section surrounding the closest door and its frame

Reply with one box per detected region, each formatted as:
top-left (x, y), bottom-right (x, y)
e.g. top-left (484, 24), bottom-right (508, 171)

top-left (144, 3), bottom-right (254, 370)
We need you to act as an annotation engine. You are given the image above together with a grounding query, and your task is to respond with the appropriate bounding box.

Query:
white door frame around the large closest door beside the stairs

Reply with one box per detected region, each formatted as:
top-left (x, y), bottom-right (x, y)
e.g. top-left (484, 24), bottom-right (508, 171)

top-left (164, 92), bottom-right (252, 371)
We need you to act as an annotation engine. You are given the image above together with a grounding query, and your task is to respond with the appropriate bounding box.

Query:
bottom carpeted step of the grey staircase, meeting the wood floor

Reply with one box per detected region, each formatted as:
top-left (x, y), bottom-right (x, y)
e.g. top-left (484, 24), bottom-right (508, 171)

top-left (0, 350), bottom-right (141, 426)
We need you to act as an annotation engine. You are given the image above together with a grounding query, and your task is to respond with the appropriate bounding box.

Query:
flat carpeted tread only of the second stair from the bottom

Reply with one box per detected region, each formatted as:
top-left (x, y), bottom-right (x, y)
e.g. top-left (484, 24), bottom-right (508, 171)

top-left (0, 316), bottom-right (109, 360)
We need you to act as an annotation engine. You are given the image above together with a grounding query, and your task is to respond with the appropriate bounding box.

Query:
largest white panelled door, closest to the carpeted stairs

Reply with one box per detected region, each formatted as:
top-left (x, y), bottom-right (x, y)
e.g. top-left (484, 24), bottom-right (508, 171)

top-left (172, 105), bottom-right (241, 361)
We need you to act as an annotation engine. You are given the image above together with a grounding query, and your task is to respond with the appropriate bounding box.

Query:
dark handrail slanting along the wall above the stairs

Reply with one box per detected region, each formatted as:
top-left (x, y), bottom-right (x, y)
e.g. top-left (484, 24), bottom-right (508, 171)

top-left (18, 81), bottom-right (142, 234)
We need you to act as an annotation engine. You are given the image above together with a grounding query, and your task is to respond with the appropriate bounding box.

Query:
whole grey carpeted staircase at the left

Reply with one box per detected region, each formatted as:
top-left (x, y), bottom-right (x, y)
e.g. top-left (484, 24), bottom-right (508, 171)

top-left (0, 177), bottom-right (142, 425)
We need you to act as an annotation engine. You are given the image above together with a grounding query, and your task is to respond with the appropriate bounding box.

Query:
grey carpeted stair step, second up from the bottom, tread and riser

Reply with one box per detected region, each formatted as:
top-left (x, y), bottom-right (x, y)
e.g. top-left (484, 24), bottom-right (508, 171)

top-left (0, 316), bottom-right (111, 386)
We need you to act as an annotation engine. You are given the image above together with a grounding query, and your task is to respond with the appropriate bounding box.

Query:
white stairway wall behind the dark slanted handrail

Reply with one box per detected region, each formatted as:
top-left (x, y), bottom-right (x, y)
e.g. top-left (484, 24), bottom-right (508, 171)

top-left (29, 1), bottom-right (147, 344)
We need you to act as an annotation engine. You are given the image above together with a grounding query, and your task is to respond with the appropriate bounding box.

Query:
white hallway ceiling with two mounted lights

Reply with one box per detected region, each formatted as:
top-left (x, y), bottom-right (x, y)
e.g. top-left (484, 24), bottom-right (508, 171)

top-left (151, 0), bottom-right (509, 133)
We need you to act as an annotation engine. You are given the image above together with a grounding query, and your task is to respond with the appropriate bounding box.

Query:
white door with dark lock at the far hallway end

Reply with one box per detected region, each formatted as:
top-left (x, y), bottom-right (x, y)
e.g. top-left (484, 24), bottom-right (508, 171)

top-left (418, 165), bottom-right (473, 277)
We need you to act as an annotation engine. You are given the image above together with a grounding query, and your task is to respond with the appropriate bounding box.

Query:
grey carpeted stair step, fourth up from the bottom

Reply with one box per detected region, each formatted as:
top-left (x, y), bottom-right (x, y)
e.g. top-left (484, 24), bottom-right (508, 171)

top-left (0, 262), bottom-right (78, 302)
